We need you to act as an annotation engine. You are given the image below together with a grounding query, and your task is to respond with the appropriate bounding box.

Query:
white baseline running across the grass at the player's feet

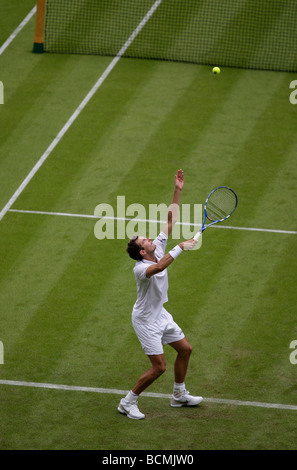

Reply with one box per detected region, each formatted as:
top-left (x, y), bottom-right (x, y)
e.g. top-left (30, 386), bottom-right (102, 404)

top-left (0, 380), bottom-right (297, 411)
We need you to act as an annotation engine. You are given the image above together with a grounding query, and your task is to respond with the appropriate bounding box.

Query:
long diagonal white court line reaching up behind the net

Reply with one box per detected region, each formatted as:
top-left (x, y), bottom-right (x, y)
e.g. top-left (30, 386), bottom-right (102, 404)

top-left (0, 0), bottom-right (162, 221)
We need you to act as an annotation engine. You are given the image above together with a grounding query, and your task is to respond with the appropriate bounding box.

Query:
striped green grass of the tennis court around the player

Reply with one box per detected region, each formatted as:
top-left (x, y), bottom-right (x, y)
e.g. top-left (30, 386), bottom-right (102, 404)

top-left (0, 0), bottom-right (297, 450)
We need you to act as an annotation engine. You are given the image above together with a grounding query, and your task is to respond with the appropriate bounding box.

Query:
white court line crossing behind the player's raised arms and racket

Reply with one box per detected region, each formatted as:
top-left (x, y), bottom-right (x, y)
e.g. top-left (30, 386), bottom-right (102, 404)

top-left (9, 209), bottom-right (297, 235)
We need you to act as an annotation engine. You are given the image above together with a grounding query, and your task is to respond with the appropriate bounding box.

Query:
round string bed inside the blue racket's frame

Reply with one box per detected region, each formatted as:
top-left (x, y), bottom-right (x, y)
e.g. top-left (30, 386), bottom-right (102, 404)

top-left (206, 188), bottom-right (237, 221)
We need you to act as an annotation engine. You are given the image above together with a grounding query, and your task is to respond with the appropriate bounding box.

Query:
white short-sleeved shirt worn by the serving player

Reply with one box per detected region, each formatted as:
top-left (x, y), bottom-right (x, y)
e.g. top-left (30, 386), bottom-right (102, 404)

top-left (132, 232), bottom-right (168, 321)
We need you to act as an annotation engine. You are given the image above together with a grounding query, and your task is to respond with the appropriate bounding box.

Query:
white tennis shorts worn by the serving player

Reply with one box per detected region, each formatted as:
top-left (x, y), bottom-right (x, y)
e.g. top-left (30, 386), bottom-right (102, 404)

top-left (132, 307), bottom-right (185, 356)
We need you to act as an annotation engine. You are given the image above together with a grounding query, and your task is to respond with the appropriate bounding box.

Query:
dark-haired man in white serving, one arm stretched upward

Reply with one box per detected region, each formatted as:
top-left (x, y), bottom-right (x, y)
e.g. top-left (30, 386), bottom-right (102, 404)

top-left (118, 170), bottom-right (203, 419)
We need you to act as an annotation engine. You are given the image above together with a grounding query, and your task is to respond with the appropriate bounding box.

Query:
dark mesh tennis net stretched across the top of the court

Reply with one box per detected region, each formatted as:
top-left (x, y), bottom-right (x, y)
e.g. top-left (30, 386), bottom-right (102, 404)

top-left (44, 0), bottom-right (297, 72)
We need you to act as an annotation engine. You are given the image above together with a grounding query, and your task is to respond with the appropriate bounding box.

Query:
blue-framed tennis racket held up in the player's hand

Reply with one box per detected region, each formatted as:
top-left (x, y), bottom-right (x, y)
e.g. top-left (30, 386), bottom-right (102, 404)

top-left (194, 186), bottom-right (238, 240)
